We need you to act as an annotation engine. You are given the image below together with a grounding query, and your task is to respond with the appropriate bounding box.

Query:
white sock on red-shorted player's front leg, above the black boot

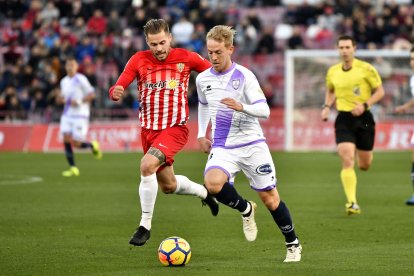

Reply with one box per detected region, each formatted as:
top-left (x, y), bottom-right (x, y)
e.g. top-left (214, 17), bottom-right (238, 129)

top-left (139, 173), bottom-right (158, 230)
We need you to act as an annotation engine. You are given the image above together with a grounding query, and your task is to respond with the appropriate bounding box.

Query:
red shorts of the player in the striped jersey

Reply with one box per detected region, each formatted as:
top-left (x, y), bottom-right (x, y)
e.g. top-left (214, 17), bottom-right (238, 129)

top-left (141, 125), bottom-right (188, 167)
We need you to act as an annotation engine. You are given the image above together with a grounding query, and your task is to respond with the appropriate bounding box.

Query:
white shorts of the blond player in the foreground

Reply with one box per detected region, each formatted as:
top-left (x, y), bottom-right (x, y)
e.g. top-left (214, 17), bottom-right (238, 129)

top-left (204, 143), bottom-right (277, 191)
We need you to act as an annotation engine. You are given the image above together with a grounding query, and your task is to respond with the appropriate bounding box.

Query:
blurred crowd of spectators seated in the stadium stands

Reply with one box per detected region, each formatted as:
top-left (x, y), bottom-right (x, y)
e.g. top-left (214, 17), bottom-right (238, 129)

top-left (0, 0), bottom-right (414, 123)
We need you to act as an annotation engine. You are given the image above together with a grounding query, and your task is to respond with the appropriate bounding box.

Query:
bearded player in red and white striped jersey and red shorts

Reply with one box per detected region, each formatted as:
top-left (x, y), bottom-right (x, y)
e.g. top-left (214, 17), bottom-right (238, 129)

top-left (109, 19), bottom-right (218, 246)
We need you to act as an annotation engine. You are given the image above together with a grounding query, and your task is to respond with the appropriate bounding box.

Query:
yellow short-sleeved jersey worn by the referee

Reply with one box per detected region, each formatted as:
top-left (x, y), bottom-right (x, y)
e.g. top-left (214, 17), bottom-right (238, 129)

top-left (326, 59), bottom-right (382, 111)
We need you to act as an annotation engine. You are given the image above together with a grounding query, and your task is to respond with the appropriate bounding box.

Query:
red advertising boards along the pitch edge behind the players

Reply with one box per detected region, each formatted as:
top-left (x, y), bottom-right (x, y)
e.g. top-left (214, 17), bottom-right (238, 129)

top-left (0, 114), bottom-right (414, 152)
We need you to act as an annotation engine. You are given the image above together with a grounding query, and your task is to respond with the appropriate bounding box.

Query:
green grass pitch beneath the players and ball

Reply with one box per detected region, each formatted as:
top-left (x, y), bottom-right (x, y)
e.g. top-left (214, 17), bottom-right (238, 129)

top-left (0, 152), bottom-right (414, 276)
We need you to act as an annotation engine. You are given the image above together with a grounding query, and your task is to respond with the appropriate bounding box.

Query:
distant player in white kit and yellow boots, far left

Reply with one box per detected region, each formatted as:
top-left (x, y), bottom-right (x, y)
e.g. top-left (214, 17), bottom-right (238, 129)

top-left (57, 58), bottom-right (102, 177)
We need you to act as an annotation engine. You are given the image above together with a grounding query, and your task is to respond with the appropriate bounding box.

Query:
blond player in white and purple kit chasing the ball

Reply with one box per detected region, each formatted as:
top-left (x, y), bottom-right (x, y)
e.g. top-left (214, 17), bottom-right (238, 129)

top-left (196, 25), bottom-right (302, 262)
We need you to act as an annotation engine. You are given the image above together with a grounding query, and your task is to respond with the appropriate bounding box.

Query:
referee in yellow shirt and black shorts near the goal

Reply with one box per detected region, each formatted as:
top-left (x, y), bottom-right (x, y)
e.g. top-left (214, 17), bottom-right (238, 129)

top-left (321, 35), bottom-right (384, 215)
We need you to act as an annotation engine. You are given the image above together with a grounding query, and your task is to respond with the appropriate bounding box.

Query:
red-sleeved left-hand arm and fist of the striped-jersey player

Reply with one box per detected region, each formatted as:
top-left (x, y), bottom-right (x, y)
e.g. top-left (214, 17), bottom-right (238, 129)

top-left (109, 54), bottom-right (138, 101)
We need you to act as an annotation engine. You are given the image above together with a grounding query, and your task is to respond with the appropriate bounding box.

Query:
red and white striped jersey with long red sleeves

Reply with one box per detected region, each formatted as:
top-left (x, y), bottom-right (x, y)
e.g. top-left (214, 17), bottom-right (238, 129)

top-left (109, 48), bottom-right (211, 130)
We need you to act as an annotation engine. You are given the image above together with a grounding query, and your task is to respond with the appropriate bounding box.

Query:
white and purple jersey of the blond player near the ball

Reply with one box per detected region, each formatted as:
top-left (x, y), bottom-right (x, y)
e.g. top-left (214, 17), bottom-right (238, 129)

top-left (196, 63), bottom-right (266, 149)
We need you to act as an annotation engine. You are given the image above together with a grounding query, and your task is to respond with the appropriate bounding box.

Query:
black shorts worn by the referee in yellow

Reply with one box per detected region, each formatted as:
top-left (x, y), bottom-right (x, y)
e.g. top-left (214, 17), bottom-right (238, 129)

top-left (335, 111), bottom-right (375, 151)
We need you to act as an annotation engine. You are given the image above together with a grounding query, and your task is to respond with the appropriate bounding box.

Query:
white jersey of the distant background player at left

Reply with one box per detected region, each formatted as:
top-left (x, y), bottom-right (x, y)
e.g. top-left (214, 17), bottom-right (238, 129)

top-left (60, 73), bottom-right (95, 118)
